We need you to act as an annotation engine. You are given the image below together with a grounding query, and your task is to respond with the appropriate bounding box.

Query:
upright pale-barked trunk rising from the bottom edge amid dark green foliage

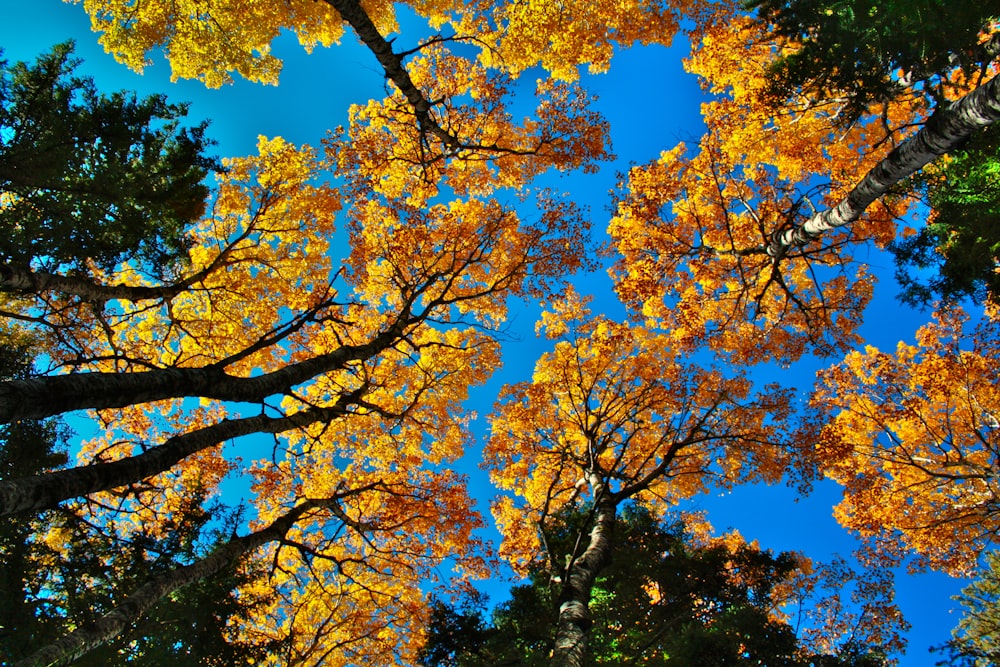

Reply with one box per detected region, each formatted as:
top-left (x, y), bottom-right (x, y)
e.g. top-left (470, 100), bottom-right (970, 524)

top-left (552, 486), bottom-right (616, 667)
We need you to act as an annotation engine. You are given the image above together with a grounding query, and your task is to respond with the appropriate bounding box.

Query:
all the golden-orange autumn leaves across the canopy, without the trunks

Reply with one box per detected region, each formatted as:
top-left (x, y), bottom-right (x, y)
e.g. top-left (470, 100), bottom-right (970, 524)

top-left (19, 0), bottom-right (988, 665)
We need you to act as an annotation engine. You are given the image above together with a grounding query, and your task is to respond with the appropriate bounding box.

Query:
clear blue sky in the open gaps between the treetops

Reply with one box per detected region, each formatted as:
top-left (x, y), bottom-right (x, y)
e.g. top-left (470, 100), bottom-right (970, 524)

top-left (0, 0), bottom-right (964, 667)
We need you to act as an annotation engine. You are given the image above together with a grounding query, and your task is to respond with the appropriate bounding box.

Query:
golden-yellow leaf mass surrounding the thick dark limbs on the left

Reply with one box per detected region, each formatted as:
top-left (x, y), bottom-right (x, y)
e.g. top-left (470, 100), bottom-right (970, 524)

top-left (10, 96), bottom-right (587, 665)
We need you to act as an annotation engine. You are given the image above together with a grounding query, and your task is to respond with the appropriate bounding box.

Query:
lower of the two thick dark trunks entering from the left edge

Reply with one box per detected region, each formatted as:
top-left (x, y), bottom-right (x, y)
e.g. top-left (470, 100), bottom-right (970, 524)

top-left (0, 387), bottom-right (367, 516)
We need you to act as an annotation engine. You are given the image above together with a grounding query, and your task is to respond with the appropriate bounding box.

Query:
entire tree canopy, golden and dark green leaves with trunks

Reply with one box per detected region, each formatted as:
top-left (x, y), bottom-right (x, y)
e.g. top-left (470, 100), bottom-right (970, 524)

top-left (0, 0), bottom-right (1000, 667)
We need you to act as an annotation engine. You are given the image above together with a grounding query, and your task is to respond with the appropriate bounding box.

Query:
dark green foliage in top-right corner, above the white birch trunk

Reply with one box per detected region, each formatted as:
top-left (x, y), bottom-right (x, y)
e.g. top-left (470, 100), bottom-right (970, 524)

top-left (747, 0), bottom-right (1000, 124)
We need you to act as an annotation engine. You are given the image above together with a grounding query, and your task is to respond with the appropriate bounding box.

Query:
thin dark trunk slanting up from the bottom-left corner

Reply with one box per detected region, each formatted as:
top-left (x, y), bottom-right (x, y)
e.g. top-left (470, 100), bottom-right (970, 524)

top-left (13, 500), bottom-right (320, 667)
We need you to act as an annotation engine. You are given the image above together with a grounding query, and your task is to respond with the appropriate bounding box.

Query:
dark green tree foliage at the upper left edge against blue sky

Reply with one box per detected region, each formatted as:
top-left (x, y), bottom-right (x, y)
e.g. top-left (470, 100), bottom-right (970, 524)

top-left (0, 43), bottom-right (217, 274)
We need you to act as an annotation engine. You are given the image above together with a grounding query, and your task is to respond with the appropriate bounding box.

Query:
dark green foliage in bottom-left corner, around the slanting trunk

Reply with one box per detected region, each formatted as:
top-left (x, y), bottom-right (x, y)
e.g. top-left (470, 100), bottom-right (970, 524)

top-left (0, 490), bottom-right (280, 667)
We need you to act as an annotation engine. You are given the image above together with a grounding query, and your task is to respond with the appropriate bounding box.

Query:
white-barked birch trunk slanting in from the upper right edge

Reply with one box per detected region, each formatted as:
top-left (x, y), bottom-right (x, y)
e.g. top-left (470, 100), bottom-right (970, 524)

top-left (767, 77), bottom-right (1000, 261)
